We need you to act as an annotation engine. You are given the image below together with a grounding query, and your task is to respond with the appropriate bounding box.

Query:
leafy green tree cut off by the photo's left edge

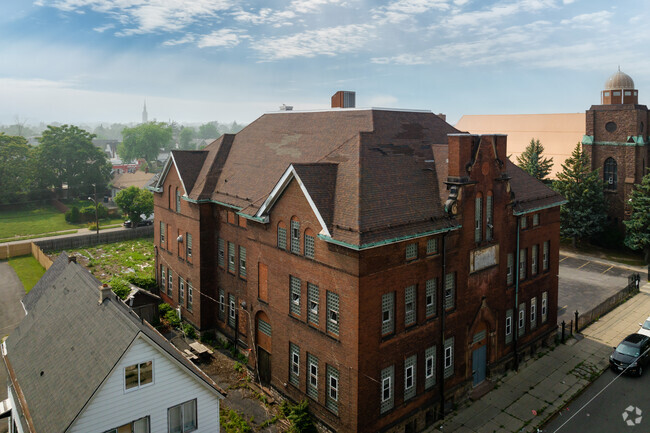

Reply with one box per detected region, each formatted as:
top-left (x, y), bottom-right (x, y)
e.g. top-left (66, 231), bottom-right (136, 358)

top-left (0, 132), bottom-right (36, 203)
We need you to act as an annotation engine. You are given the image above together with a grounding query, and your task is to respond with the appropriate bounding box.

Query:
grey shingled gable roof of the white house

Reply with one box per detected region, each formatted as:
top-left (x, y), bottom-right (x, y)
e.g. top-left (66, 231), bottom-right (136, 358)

top-left (5, 255), bottom-right (220, 432)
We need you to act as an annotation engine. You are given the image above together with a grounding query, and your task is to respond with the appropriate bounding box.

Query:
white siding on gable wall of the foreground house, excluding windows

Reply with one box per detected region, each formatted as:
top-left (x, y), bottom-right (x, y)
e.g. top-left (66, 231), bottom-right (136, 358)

top-left (68, 337), bottom-right (220, 433)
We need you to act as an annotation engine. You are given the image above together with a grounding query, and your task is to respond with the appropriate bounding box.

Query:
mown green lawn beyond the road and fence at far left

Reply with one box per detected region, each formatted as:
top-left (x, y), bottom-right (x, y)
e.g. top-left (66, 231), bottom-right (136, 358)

top-left (0, 205), bottom-right (122, 242)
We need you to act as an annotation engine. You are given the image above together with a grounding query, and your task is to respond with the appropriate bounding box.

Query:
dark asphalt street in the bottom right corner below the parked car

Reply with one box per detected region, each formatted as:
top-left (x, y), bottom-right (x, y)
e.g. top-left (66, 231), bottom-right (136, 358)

top-left (543, 369), bottom-right (650, 433)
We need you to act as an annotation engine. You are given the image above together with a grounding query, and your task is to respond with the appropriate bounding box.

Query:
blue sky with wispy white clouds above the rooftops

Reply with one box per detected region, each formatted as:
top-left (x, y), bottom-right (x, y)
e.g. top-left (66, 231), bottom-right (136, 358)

top-left (0, 0), bottom-right (650, 124)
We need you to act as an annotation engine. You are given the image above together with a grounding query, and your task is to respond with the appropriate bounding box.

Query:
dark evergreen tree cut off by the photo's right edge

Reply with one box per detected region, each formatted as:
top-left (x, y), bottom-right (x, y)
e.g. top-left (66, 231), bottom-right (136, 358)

top-left (623, 172), bottom-right (650, 276)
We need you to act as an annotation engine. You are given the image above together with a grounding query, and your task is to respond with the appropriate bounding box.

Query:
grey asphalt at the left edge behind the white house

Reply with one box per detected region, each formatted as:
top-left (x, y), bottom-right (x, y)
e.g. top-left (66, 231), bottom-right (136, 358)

top-left (0, 261), bottom-right (25, 433)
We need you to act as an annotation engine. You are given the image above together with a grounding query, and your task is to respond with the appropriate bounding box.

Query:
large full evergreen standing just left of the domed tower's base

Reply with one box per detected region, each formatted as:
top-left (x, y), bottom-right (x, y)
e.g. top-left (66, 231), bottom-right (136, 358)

top-left (553, 143), bottom-right (606, 247)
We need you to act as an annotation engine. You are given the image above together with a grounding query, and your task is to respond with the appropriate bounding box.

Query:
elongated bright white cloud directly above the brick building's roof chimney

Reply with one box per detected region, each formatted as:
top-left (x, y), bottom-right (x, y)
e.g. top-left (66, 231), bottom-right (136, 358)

top-left (252, 24), bottom-right (373, 60)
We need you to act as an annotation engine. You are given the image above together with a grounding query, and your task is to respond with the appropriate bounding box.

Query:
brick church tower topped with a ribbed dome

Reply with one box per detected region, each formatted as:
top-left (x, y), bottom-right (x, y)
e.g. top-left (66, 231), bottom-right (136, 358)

top-left (582, 68), bottom-right (650, 224)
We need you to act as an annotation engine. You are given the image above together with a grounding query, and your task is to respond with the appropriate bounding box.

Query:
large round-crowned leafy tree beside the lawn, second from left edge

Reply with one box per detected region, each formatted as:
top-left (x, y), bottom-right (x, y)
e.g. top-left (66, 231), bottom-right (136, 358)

top-left (37, 125), bottom-right (111, 196)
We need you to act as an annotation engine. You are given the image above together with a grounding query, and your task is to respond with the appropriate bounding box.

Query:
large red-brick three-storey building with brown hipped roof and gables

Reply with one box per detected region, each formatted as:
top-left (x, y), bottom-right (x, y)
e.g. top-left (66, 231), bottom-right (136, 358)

top-left (148, 95), bottom-right (562, 432)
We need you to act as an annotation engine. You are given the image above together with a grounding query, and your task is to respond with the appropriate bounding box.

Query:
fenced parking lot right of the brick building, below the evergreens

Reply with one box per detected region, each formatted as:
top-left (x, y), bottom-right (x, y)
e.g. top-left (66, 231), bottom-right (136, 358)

top-left (558, 251), bottom-right (645, 323)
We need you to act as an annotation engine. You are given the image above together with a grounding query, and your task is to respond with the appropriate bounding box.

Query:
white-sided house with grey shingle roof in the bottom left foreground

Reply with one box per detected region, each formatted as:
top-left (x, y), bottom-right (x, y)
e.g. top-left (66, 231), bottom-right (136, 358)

top-left (1, 255), bottom-right (224, 433)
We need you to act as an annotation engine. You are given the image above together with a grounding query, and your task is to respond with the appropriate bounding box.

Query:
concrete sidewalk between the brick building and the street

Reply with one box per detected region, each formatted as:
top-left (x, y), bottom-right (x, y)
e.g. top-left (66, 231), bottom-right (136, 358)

top-left (426, 283), bottom-right (650, 433)
